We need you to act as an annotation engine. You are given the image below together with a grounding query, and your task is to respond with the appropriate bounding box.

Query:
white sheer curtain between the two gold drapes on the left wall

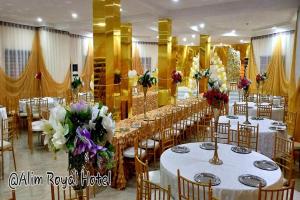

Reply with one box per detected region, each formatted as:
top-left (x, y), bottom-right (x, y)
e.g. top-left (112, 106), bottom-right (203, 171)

top-left (40, 28), bottom-right (89, 83)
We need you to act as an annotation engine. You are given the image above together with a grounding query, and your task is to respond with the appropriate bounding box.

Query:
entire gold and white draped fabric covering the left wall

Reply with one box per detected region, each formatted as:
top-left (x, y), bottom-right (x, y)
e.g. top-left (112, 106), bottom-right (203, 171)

top-left (0, 22), bottom-right (93, 102)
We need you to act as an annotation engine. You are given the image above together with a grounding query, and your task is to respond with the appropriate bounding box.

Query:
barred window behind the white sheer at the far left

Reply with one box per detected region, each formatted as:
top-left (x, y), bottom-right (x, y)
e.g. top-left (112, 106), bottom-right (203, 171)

top-left (5, 49), bottom-right (31, 78)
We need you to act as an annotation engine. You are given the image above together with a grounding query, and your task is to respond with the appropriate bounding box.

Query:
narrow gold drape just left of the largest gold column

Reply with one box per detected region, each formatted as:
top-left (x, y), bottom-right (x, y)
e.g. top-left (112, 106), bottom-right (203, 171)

top-left (81, 41), bottom-right (94, 92)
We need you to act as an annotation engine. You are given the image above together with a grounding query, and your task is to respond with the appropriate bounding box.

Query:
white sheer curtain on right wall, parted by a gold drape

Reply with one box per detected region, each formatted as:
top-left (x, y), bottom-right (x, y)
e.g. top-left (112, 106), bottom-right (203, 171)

top-left (252, 32), bottom-right (295, 79)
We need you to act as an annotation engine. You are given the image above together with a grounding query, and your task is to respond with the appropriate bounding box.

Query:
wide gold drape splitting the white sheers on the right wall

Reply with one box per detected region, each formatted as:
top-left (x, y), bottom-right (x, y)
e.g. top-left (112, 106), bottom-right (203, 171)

top-left (264, 36), bottom-right (288, 96)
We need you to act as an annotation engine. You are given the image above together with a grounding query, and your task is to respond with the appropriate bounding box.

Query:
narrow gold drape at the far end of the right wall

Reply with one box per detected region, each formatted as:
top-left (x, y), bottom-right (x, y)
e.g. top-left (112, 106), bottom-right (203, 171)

top-left (247, 42), bottom-right (258, 92)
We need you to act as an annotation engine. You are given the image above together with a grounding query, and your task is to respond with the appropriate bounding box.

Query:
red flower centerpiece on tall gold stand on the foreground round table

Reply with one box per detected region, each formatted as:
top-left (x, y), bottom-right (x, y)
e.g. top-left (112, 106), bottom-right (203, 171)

top-left (203, 78), bottom-right (229, 165)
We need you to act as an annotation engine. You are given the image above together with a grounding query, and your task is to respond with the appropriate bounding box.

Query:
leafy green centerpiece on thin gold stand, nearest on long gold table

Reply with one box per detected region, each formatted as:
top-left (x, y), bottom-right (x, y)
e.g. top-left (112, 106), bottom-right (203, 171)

top-left (138, 71), bottom-right (157, 120)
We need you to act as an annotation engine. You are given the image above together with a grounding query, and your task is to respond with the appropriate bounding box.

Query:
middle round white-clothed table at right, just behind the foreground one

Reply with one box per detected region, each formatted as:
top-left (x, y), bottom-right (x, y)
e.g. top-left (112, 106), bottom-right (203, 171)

top-left (219, 115), bottom-right (286, 158)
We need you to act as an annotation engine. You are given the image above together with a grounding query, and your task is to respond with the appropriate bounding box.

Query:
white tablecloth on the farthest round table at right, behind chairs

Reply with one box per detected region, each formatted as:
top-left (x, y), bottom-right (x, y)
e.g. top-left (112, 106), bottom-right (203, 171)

top-left (229, 102), bottom-right (284, 121)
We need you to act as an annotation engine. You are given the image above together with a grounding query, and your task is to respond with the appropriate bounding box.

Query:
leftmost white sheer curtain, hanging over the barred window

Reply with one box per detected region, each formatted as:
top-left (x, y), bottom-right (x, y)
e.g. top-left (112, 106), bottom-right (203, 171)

top-left (0, 22), bottom-right (35, 78)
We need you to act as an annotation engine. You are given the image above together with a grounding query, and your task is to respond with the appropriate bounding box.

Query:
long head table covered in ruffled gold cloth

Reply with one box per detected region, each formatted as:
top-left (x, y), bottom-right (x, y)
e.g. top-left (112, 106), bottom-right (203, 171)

top-left (113, 98), bottom-right (203, 189)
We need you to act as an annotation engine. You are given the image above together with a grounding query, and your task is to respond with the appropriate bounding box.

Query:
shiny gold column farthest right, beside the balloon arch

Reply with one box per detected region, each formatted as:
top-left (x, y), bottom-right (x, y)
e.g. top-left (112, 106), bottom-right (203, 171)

top-left (199, 35), bottom-right (211, 93)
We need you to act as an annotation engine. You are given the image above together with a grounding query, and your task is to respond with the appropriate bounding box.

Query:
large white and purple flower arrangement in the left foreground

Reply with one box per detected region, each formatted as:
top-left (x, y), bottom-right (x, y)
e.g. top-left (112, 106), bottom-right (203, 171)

top-left (43, 101), bottom-right (115, 196)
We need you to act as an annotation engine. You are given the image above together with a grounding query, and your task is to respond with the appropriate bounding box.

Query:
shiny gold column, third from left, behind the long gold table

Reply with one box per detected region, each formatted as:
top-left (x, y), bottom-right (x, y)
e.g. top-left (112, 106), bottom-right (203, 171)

top-left (158, 19), bottom-right (172, 101)
